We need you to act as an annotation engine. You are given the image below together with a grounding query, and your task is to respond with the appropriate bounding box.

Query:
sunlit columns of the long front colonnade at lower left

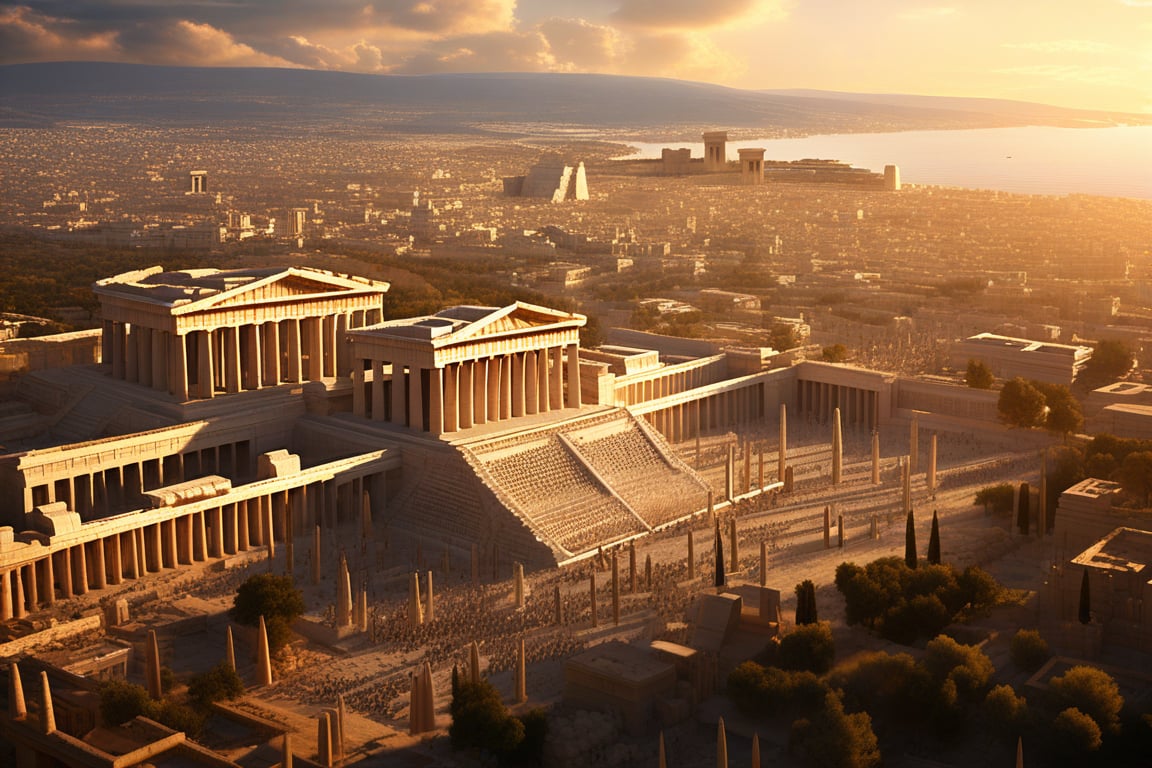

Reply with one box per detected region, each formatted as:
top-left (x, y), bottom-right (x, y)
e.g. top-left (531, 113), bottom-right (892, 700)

top-left (0, 471), bottom-right (384, 621)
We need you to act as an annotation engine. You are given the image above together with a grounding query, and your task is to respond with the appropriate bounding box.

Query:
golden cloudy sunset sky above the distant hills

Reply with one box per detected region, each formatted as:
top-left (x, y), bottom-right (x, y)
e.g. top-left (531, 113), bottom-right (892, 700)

top-left (0, 0), bottom-right (1152, 113)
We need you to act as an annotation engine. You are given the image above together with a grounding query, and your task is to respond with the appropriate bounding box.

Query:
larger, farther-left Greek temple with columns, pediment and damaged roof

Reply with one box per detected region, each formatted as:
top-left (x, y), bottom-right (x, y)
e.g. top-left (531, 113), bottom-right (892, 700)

top-left (93, 267), bottom-right (388, 402)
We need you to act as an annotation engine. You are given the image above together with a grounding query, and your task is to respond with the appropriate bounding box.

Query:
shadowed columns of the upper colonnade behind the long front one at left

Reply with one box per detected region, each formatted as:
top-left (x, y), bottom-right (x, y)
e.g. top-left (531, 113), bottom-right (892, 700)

top-left (24, 440), bottom-right (252, 520)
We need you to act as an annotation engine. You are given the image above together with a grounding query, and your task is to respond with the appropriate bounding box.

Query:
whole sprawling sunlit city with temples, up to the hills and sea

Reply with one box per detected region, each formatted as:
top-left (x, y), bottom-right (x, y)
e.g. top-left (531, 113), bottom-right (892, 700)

top-left (0, 22), bottom-right (1152, 768)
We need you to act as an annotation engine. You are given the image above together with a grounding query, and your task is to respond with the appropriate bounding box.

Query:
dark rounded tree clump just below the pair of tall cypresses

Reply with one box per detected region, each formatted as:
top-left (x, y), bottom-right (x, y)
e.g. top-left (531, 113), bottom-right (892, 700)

top-left (835, 557), bottom-right (1002, 645)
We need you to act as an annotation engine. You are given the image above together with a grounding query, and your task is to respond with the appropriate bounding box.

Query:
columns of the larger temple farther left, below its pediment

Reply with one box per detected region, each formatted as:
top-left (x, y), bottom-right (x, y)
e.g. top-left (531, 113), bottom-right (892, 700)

top-left (103, 310), bottom-right (380, 401)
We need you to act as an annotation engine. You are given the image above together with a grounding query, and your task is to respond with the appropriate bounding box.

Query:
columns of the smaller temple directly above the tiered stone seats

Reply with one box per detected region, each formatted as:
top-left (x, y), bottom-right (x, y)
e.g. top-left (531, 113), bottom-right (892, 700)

top-left (353, 344), bottom-right (581, 434)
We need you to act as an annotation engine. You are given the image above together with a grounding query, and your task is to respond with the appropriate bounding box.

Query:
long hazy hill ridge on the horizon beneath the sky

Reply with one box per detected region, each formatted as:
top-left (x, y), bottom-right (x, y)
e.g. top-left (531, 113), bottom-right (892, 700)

top-left (0, 62), bottom-right (1152, 135)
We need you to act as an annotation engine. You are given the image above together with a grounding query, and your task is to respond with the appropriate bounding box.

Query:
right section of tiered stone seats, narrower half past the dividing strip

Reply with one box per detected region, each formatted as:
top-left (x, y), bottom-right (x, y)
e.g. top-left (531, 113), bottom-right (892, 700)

top-left (566, 411), bottom-right (708, 527)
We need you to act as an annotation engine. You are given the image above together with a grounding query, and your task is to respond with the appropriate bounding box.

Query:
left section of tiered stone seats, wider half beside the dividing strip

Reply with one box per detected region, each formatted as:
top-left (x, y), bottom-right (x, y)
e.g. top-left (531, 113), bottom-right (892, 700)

top-left (471, 431), bottom-right (645, 554)
